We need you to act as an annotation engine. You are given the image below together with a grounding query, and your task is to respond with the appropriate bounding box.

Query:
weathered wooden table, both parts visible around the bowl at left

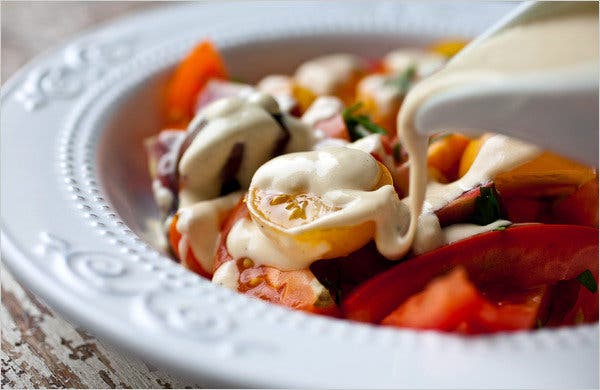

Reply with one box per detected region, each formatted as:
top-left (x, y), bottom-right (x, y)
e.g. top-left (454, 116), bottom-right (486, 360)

top-left (0, 1), bottom-right (202, 388)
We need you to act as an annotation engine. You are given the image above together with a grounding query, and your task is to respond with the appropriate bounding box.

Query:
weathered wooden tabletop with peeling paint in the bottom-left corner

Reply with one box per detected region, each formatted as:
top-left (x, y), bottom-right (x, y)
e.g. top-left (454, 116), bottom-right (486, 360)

top-left (0, 267), bottom-right (202, 389)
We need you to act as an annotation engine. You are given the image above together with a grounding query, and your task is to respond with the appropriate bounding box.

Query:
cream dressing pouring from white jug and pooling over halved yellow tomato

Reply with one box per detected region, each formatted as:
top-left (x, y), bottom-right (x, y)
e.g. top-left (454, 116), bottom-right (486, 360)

top-left (221, 9), bottom-right (598, 269)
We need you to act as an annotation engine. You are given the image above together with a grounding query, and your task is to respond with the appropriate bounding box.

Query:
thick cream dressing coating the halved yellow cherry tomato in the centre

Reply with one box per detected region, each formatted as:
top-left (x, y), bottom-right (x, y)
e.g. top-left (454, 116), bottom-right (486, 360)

top-left (227, 147), bottom-right (408, 269)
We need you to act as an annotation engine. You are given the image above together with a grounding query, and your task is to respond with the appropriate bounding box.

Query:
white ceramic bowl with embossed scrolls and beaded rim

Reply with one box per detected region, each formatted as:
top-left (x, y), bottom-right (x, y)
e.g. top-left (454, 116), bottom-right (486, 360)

top-left (0, 1), bottom-right (598, 388)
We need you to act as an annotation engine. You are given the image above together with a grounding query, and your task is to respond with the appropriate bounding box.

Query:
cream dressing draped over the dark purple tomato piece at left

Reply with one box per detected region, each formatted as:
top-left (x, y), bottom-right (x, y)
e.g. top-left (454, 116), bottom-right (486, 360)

top-left (179, 93), bottom-right (314, 207)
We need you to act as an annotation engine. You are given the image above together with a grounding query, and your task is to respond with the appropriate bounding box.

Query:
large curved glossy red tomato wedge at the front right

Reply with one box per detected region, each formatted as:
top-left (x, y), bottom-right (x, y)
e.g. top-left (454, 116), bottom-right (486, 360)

top-left (342, 224), bottom-right (598, 323)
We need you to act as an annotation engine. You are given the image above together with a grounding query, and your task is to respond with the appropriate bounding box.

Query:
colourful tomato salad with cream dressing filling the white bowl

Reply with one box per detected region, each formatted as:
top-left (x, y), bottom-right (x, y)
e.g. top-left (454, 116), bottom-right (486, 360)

top-left (146, 41), bottom-right (598, 334)
